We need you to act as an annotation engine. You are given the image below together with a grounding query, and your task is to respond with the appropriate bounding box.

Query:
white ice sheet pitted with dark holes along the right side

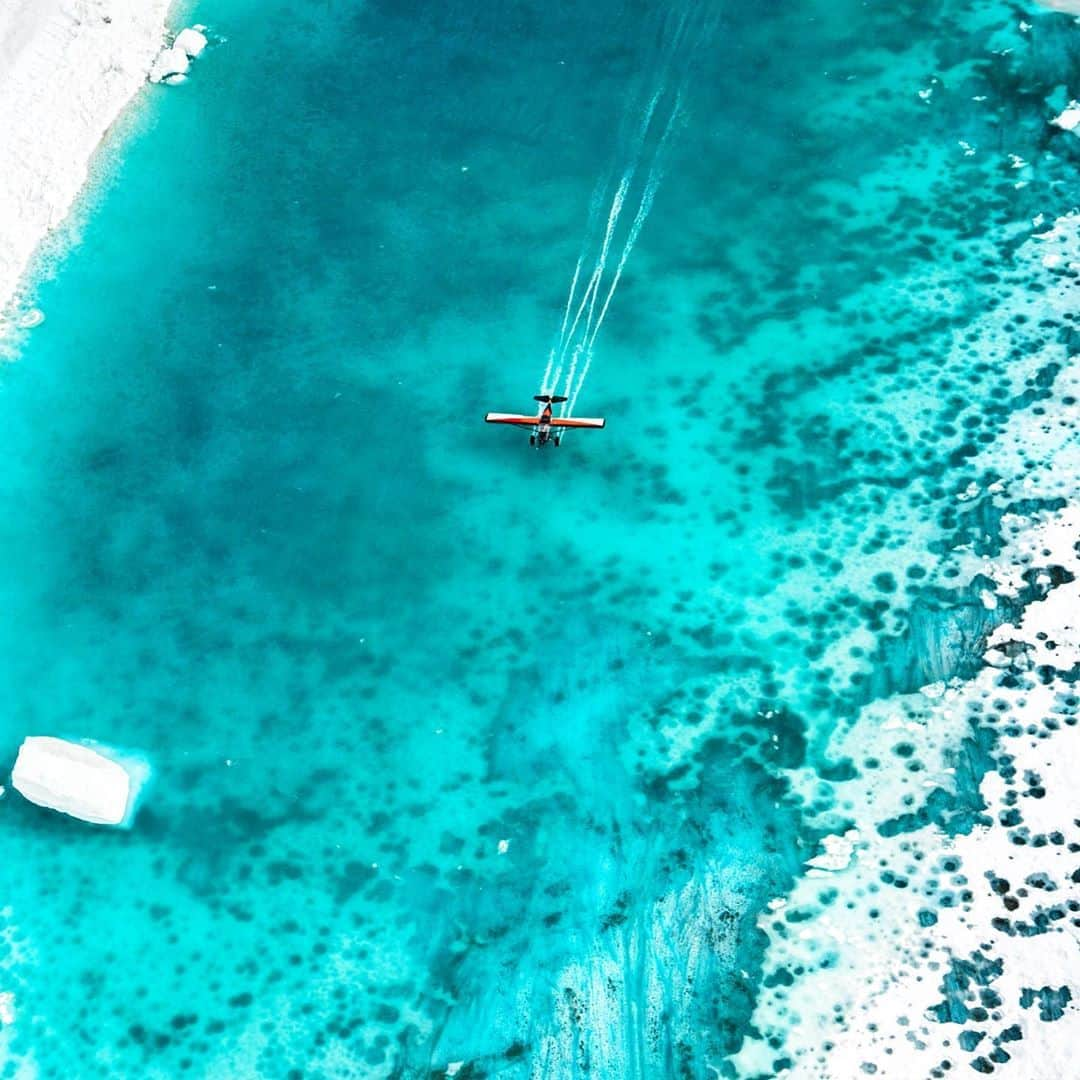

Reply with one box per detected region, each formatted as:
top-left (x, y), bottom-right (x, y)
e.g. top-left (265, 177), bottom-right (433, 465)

top-left (734, 216), bottom-right (1080, 1080)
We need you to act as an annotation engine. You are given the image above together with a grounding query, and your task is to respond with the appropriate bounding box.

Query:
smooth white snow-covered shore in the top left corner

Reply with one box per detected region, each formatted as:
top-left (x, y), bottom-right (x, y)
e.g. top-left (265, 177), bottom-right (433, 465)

top-left (0, 0), bottom-right (171, 332)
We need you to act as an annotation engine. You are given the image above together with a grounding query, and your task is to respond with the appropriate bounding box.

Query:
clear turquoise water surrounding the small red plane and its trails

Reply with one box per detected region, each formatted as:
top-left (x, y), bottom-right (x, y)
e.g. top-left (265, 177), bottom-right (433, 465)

top-left (0, 0), bottom-right (1074, 1078)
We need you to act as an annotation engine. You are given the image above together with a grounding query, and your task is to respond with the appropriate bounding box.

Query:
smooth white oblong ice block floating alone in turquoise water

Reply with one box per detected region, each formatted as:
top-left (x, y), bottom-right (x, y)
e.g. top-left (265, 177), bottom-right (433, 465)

top-left (11, 735), bottom-right (144, 825)
